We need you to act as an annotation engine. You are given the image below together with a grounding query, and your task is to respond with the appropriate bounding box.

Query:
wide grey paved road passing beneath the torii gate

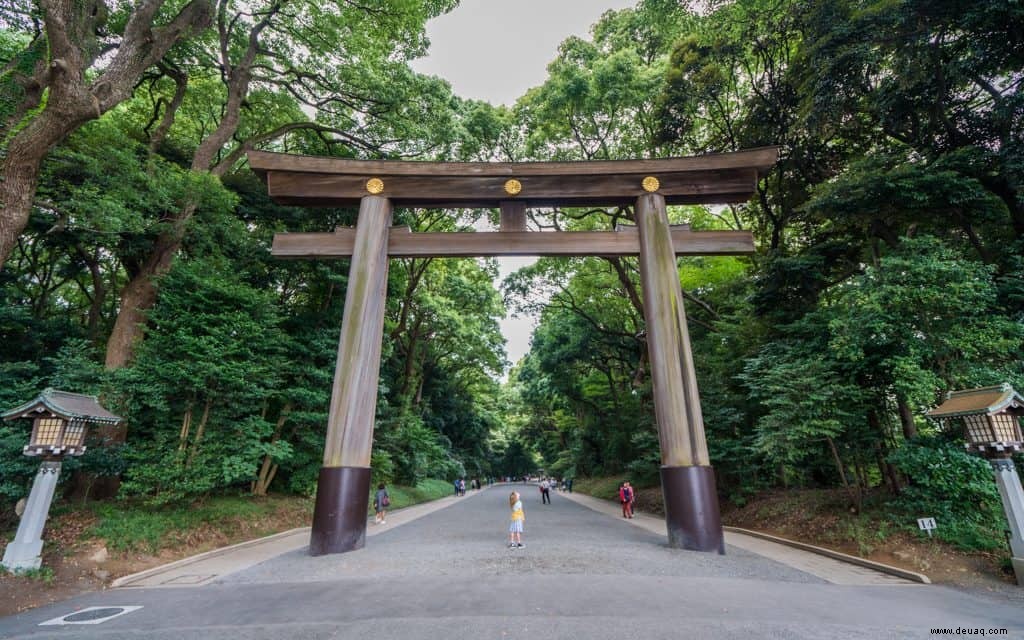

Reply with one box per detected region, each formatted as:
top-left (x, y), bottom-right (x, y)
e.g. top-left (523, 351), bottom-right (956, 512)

top-left (0, 487), bottom-right (1024, 640)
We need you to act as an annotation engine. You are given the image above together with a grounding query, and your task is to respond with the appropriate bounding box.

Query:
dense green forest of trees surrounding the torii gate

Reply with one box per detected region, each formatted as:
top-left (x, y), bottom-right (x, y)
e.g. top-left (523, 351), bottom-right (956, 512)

top-left (0, 0), bottom-right (1024, 539)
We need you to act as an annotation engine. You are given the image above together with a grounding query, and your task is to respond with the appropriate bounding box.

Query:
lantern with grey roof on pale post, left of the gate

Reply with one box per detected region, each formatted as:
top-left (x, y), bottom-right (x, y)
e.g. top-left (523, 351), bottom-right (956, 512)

top-left (0, 389), bottom-right (121, 570)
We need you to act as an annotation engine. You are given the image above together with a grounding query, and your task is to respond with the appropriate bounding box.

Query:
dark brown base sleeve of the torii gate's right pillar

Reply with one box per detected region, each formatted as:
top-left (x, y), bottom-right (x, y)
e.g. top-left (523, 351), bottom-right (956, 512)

top-left (662, 467), bottom-right (725, 555)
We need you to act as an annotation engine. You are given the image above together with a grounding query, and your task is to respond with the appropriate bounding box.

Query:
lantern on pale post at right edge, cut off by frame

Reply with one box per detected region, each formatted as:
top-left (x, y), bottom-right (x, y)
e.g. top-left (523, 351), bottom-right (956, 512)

top-left (926, 384), bottom-right (1024, 585)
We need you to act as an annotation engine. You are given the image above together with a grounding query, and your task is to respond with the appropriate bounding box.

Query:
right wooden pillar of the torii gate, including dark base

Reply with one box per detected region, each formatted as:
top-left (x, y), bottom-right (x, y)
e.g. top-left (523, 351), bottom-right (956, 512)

top-left (636, 194), bottom-right (725, 553)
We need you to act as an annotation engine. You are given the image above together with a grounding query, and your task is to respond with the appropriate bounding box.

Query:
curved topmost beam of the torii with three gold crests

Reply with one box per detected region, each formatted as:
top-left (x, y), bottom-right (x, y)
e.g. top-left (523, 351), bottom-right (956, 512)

top-left (249, 146), bottom-right (778, 208)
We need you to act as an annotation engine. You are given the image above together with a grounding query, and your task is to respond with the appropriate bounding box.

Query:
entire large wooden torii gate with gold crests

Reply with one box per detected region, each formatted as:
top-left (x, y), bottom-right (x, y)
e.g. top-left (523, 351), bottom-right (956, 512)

top-left (249, 147), bottom-right (778, 555)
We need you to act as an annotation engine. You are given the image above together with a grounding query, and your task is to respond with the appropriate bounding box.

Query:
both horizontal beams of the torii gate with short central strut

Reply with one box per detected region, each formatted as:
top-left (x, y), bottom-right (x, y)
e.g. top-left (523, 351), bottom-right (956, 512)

top-left (249, 146), bottom-right (778, 258)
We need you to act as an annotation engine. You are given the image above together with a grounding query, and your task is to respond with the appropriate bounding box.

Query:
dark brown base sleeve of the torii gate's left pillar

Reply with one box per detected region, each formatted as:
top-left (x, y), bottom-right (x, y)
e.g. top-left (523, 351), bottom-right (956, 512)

top-left (309, 467), bottom-right (370, 556)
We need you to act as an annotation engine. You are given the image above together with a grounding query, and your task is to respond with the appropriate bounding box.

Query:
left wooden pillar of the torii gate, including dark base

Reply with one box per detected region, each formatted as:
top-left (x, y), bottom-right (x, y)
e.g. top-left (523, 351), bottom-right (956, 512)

top-left (309, 196), bottom-right (391, 556)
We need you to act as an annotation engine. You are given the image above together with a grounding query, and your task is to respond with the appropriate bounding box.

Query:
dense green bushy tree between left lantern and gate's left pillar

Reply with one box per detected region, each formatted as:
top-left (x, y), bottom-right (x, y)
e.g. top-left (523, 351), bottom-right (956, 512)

top-left (115, 262), bottom-right (289, 500)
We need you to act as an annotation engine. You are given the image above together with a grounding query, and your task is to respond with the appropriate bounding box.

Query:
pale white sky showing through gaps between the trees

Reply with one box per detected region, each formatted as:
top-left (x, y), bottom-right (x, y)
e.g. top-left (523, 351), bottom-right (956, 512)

top-left (412, 0), bottom-right (636, 372)
